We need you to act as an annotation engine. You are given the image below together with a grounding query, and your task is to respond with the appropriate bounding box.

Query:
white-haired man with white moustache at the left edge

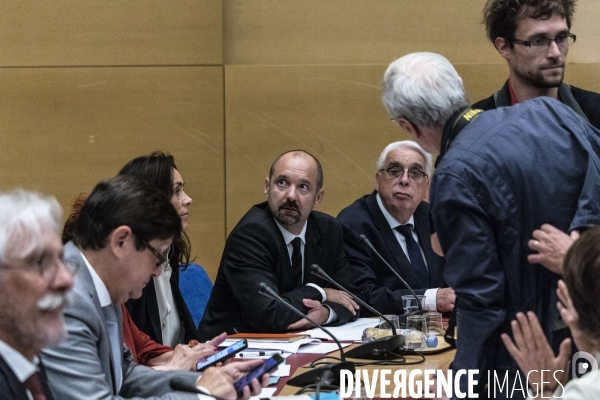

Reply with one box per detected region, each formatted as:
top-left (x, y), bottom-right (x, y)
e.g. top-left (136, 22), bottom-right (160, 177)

top-left (0, 190), bottom-right (73, 400)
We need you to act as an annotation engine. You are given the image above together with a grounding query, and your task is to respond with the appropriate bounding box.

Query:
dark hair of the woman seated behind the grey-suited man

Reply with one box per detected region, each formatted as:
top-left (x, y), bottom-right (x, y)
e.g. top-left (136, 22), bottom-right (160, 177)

top-left (119, 151), bottom-right (192, 269)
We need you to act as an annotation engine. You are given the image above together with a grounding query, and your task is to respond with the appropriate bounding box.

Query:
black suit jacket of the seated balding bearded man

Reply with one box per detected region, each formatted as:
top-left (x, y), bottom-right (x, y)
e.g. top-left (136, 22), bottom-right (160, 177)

top-left (198, 202), bottom-right (354, 340)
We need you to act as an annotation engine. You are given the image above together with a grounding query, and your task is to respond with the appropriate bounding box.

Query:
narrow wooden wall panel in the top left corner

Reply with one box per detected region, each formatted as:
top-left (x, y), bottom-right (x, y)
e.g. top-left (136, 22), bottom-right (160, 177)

top-left (0, 0), bottom-right (223, 66)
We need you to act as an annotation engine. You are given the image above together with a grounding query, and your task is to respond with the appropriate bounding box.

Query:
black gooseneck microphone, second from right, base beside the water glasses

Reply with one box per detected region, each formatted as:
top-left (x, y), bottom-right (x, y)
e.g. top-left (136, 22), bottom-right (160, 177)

top-left (310, 264), bottom-right (405, 360)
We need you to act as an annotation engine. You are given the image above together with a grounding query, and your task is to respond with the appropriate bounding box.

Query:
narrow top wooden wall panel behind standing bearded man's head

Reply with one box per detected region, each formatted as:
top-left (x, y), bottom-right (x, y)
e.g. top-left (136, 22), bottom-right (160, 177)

top-left (224, 0), bottom-right (600, 65)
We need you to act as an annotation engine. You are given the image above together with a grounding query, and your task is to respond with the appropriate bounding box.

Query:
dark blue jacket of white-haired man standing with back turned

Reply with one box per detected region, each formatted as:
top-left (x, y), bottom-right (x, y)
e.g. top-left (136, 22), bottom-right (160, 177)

top-left (431, 97), bottom-right (600, 396)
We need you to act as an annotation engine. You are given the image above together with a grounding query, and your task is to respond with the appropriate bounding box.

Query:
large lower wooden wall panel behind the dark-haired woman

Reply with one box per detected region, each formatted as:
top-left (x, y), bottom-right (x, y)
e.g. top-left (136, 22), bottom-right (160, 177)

top-left (0, 67), bottom-right (225, 276)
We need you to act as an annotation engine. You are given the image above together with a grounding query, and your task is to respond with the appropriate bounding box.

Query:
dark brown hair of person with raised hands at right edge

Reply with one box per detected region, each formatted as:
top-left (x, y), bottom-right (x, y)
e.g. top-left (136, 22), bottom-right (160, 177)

top-left (563, 226), bottom-right (600, 337)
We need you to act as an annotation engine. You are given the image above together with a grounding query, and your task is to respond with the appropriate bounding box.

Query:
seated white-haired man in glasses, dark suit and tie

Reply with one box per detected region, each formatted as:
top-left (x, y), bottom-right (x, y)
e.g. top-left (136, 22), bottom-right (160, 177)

top-left (337, 140), bottom-right (454, 315)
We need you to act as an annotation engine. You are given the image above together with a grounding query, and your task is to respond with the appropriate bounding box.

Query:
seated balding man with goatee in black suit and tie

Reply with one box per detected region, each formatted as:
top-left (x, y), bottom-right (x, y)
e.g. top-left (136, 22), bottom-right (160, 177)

top-left (199, 151), bottom-right (358, 339)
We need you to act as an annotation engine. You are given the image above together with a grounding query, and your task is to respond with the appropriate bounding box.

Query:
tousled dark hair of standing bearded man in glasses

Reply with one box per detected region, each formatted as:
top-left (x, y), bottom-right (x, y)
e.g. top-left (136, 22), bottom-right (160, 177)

top-left (483, 0), bottom-right (576, 46)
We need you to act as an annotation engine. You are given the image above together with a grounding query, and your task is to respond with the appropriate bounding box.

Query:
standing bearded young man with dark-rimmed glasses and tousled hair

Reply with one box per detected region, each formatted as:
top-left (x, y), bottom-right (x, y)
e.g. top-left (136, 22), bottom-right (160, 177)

top-left (473, 0), bottom-right (600, 129)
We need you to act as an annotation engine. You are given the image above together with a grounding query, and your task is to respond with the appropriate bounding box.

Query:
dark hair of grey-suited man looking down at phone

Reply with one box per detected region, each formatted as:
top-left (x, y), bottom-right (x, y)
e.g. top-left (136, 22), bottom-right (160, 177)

top-left (73, 175), bottom-right (181, 250)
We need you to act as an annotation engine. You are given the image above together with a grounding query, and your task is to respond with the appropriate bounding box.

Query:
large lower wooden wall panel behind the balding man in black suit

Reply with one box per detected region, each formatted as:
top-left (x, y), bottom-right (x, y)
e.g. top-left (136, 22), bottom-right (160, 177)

top-left (225, 60), bottom-right (600, 232)
